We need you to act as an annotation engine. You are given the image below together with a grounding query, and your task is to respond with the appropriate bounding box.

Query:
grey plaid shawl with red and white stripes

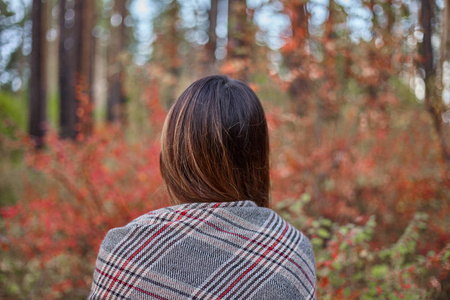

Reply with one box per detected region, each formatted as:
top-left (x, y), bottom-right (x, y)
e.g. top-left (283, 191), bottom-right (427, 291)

top-left (89, 200), bottom-right (316, 299)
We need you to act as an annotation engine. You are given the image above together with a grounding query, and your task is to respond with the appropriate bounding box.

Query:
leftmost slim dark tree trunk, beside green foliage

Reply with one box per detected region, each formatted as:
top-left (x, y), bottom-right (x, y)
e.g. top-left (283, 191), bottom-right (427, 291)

top-left (29, 0), bottom-right (47, 148)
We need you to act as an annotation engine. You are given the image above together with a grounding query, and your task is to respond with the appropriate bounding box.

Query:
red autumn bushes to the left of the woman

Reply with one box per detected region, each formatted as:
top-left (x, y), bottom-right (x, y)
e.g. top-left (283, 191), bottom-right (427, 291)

top-left (0, 82), bottom-right (167, 299)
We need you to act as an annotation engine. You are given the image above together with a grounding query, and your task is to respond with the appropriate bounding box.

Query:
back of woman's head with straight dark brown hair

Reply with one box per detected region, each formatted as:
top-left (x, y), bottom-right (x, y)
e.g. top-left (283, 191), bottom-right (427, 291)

top-left (160, 75), bottom-right (269, 206)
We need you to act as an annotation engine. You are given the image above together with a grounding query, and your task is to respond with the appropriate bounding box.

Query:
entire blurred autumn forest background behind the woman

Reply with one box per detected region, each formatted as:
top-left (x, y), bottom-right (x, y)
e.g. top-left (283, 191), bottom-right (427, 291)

top-left (0, 0), bottom-right (450, 299)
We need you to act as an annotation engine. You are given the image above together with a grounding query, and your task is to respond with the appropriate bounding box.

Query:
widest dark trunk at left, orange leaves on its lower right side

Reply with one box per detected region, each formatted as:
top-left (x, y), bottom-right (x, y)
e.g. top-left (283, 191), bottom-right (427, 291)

top-left (59, 0), bottom-right (95, 139)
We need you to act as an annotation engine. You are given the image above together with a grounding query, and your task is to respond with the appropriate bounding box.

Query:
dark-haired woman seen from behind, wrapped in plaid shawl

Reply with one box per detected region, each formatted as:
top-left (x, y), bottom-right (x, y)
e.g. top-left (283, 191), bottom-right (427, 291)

top-left (90, 76), bottom-right (316, 299)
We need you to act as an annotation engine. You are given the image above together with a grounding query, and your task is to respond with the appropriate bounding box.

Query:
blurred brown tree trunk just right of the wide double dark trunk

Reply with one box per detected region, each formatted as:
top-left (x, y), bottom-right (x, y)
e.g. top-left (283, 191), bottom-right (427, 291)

top-left (107, 0), bottom-right (127, 122)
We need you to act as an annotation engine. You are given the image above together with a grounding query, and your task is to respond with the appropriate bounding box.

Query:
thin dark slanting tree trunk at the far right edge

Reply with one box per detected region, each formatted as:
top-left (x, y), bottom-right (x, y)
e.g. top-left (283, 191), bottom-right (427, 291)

top-left (419, 0), bottom-right (450, 165)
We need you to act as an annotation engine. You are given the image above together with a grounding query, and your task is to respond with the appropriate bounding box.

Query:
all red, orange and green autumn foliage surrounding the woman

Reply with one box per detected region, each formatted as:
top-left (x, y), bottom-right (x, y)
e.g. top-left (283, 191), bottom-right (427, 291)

top-left (0, 0), bottom-right (450, 299)
